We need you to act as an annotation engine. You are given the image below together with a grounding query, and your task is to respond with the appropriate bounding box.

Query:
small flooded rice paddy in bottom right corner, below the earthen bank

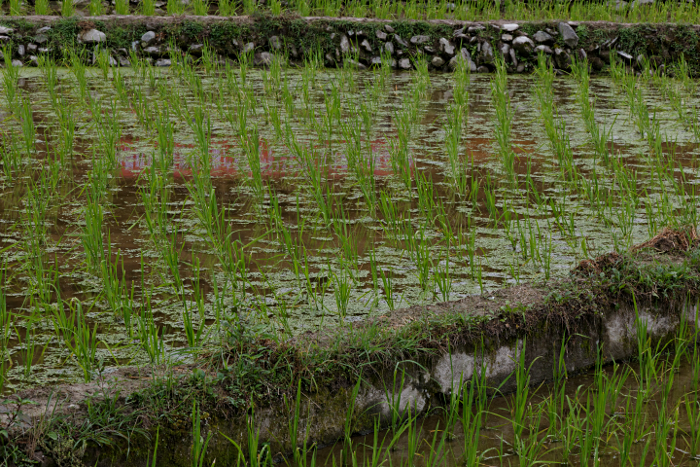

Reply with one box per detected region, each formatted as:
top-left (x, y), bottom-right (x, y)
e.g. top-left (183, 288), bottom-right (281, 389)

top-left (316, 341), bottom-right (700, 467)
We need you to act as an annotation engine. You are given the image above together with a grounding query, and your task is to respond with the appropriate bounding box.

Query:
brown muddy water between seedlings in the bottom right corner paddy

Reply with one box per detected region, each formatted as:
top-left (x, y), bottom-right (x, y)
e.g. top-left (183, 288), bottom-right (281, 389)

top-left (316, 358), bottom-right (700, 467)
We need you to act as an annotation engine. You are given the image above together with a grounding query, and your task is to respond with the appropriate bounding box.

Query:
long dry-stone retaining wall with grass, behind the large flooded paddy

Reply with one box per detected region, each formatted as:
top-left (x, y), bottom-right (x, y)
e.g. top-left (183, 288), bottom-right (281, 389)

top-left (0, 16), bottom-right (700, 73)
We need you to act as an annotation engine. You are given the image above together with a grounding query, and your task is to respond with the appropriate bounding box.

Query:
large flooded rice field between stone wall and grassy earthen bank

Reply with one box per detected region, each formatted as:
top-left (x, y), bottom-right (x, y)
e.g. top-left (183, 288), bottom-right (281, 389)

top-left (0, 51), bottom-right (700, 393)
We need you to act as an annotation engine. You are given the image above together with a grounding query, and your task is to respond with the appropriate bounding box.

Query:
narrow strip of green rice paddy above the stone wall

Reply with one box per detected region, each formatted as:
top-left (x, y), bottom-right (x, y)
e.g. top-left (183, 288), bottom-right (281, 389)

top-left (6, 0), bottom-right (700, 24)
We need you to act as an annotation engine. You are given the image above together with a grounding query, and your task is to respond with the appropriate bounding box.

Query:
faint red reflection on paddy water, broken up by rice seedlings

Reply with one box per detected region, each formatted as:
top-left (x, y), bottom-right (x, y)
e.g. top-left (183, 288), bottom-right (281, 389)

top-left (118, 135), bottom-right (402, 178)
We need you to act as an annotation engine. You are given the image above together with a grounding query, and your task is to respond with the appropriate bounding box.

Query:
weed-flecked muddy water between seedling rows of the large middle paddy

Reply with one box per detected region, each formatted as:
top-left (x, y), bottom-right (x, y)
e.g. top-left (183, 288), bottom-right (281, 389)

top-left (0, 69), bottom-right (698, 391)
